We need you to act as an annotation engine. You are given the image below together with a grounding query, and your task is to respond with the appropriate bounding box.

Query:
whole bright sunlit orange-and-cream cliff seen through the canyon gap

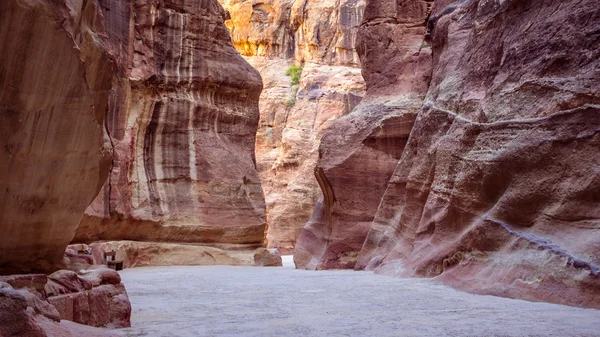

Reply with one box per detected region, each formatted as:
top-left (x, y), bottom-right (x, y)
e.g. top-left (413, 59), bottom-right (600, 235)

top-left (221, 0), bottom-right (364, 253)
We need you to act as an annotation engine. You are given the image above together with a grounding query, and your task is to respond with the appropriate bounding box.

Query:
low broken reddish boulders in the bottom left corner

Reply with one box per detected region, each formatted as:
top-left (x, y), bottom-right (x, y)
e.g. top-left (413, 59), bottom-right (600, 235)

top-left (0, 269), bottom-right (131, 337)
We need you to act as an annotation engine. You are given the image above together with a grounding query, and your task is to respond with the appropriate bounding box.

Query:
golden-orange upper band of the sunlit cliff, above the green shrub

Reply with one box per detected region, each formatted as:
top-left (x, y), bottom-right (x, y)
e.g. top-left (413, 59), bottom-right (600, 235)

top-left (220, 0), bottom-right (365, 66)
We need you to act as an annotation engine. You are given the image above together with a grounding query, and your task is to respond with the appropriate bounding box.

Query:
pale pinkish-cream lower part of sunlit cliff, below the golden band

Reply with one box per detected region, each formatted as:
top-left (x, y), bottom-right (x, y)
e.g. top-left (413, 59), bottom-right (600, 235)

top-left (250, 57), bottom-right (363, 252)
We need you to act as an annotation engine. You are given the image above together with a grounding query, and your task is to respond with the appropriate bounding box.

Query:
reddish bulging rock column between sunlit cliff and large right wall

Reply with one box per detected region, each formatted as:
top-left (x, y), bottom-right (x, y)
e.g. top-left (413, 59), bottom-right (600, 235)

top-left (294, 1), bottom-right (431, 269)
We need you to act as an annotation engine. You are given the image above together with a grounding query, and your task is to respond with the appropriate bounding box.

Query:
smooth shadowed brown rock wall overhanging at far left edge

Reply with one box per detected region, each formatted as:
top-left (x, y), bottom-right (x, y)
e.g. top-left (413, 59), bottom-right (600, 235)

top-left (0, 0), bottom-right (114, 274)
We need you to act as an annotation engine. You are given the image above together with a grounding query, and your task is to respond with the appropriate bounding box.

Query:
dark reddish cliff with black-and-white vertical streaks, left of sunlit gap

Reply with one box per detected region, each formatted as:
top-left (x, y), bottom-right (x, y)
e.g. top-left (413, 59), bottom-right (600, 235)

top-left (75, 0), bottom-right (265, 245)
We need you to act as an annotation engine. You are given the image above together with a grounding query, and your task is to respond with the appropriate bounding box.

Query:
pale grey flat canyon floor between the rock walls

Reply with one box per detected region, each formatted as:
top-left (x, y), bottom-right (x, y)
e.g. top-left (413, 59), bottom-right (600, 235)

top-left (118, 258), bottom-right (600, 337)
